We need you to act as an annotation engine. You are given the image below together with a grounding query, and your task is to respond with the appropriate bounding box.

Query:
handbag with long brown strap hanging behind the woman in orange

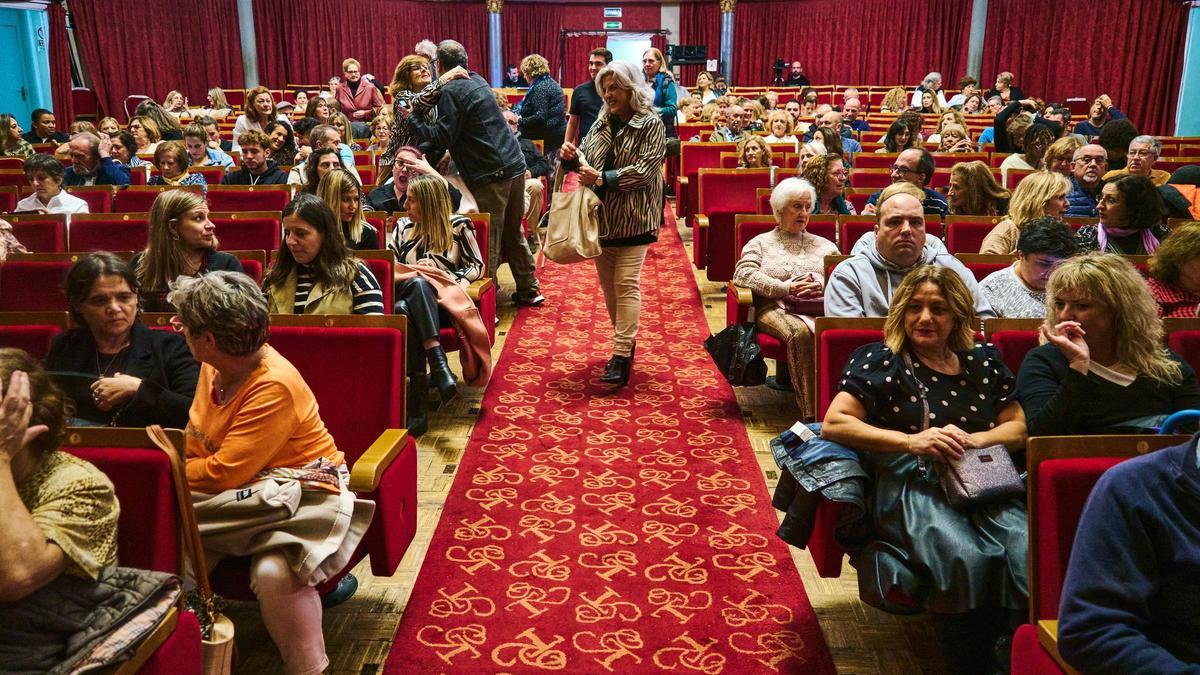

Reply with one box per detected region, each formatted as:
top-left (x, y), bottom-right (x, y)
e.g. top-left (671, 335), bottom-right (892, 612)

top-left (146, 424), bottom-right (236, 675)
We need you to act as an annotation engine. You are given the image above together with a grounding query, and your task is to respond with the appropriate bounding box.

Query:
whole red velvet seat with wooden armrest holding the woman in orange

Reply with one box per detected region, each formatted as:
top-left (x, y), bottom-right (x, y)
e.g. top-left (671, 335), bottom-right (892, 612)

top-left (212, 315), bottom-right (416, 599)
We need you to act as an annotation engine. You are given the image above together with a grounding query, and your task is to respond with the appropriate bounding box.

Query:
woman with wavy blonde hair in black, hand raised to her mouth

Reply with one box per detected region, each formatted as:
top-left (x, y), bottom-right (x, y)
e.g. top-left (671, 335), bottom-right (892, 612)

top-left (1016, 252), bottom-right (1200, 436)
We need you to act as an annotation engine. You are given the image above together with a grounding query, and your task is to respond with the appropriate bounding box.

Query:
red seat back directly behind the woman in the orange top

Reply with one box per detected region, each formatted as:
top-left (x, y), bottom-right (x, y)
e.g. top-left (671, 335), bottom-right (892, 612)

top-left (270, 316), bottom-right (404, 456)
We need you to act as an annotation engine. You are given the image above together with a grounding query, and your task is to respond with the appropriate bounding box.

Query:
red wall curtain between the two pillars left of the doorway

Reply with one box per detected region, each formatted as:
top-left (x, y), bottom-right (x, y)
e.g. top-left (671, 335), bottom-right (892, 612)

top-left (254, 0), bottom-right (489, 88)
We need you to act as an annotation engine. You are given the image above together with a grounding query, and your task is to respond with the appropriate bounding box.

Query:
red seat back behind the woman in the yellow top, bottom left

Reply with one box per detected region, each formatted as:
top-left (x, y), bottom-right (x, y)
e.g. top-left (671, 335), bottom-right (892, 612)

top-left (62, 437), bottom-right (181, 574)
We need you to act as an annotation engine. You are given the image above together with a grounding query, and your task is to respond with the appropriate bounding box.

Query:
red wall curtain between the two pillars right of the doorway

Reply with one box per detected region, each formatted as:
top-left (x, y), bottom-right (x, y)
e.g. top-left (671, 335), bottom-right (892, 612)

top-left (733, 0), bottom-right (974, 86)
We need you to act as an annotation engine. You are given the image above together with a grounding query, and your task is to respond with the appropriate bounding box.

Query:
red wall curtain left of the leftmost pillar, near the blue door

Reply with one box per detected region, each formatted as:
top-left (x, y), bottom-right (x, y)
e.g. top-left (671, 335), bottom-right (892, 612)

top-left (68, 0), bottom-right (244, 118)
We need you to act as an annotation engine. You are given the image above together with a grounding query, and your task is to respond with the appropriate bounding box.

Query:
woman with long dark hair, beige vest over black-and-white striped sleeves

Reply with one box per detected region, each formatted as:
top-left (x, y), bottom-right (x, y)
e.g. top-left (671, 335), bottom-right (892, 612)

top-left (263, 192), bottom-right (384, 315)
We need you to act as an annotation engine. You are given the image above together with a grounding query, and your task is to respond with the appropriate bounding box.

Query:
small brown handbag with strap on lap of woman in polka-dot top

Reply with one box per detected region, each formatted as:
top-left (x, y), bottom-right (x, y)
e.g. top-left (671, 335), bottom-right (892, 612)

top-left (904, 353), bottom-right (1025, 508)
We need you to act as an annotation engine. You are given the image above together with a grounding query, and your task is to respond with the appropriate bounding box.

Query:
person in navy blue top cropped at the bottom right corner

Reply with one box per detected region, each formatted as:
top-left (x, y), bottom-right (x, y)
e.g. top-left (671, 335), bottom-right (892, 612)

top-left (1058, 429), bottom-right (1200, 673)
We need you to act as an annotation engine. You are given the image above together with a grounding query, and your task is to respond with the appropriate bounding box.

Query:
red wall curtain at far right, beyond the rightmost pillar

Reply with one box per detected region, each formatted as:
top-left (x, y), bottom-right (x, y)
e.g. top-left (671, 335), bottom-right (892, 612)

top-left (979, 0), bottom-right (1188, 135)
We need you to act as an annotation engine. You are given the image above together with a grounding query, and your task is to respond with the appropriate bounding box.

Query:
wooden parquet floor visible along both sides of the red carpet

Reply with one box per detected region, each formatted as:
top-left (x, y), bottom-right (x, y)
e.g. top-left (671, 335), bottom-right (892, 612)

top-left (230, 211), bottom-right (946, 675)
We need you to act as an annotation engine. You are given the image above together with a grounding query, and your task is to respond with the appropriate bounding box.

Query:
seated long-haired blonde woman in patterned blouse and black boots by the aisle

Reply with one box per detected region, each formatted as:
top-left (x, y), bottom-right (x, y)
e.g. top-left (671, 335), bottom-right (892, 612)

top-left (388, 175), bottom-right (488, 425)
